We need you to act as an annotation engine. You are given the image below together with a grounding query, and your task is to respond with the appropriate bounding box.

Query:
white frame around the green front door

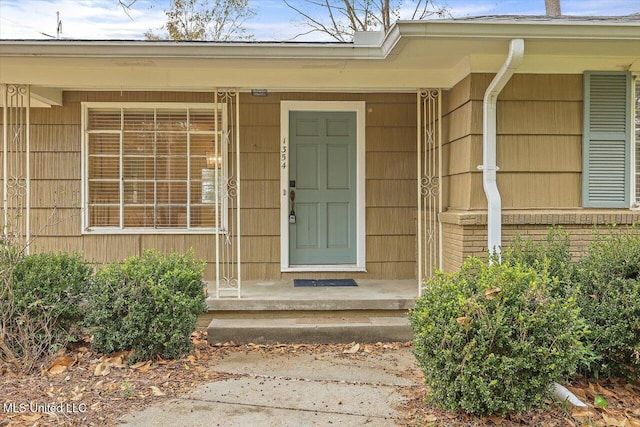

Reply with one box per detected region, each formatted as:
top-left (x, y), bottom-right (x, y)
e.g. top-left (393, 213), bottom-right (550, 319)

top-left (279, 101), bottom-right (366, 272)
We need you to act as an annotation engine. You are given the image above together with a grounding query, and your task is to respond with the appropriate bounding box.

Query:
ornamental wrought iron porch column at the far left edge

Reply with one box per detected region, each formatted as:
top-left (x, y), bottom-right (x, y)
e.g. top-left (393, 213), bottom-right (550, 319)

top-left (2, 84), bottom-right (31, 251)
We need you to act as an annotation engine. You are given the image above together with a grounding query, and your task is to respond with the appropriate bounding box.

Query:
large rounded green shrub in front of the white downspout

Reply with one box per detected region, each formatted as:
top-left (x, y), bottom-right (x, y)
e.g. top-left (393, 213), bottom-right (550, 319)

top-left (409, 258), bottom-right (584, 415)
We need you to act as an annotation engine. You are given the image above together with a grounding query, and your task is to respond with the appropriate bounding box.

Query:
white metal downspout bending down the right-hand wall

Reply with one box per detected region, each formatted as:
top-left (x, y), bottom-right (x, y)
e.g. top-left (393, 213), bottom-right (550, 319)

top-left (478, 39), bottom-right (524, 257)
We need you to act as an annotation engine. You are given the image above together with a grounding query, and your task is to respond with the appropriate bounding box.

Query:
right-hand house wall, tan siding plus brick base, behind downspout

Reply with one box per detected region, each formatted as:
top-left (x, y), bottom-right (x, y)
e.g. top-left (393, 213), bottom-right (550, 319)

top-left (441, 74), bottom-right (640, 271)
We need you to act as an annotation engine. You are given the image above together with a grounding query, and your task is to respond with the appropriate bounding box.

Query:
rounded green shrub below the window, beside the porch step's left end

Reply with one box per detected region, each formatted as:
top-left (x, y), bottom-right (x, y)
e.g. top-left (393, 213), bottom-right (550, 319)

top-left (87, 251), bottom-right (205, 361)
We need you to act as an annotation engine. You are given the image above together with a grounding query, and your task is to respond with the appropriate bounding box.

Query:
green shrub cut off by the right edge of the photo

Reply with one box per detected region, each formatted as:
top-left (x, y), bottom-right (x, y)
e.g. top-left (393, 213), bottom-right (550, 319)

top-left (574, 227), bottom-right (640, 378)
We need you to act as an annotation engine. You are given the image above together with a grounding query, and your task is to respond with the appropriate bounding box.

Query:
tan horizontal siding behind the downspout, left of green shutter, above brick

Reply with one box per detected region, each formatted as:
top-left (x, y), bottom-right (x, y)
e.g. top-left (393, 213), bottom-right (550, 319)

top-left (443, 74), bottom-right (582, 210)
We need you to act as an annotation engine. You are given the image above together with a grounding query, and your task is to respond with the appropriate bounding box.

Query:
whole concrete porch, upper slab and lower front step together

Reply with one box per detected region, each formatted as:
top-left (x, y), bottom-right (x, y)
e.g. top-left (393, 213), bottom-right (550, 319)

top-left (199, 280), bottom-right (418, 344)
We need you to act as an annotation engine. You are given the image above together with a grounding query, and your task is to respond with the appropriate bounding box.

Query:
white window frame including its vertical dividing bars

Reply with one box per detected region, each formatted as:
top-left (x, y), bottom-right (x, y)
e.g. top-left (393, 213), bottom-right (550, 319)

top-left (81, 102), bottom-right (228, 235)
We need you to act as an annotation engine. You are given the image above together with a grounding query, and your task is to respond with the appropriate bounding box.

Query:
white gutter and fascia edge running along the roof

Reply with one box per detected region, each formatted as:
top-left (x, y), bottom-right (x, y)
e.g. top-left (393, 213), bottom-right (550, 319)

top-left (0, 19), bottom-right (640, 61)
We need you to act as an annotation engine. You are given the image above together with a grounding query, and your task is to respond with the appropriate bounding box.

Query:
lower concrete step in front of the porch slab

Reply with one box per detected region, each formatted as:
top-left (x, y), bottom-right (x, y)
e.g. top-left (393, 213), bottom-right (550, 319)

top-left (207, 315), bottom-right (413, 344)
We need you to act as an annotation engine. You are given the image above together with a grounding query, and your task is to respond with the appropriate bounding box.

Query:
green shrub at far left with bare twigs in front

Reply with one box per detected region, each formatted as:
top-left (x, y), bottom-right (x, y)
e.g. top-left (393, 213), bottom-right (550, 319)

top-left (0, 249), bottom-right (92, 373)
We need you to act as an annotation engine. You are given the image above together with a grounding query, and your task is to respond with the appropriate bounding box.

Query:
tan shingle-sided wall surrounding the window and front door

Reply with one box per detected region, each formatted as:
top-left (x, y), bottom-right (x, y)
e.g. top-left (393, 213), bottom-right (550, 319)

top-left (6, 92), bottom-right (416, 280)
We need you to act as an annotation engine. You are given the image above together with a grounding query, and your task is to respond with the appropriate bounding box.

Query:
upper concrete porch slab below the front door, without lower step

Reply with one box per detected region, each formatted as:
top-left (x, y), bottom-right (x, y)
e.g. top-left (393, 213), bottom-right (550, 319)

top-left (207, 279), bottom-right (418, 311)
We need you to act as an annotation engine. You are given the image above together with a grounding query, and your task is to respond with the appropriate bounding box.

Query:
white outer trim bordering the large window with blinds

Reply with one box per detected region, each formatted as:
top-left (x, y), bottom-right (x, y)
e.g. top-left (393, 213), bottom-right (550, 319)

top-left (80, 102), bottom-right (228, 235)
